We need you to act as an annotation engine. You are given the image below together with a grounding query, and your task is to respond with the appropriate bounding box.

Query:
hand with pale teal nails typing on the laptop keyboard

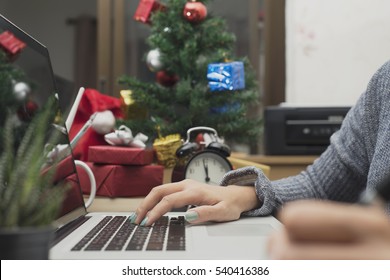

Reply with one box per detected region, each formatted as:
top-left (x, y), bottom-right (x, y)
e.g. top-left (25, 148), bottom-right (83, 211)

top-left (131, 180), bottom-right (260, 226)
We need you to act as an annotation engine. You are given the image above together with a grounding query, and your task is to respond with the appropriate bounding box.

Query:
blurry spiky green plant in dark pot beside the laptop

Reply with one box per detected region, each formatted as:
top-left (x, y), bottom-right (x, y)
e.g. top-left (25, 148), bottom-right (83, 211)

top-left (0, 97), bottom-right (65, 259)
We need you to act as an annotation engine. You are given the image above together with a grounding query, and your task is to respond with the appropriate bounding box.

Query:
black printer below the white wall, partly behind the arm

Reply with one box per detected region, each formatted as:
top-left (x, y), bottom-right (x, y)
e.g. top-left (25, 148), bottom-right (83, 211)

top-left (264, 106), bottom-right (351, 155)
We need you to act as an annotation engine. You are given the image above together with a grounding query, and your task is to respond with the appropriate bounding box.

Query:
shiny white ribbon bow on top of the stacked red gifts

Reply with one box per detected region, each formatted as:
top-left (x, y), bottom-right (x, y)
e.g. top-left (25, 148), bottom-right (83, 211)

top-left (104, 125), bottom-right (148, 148)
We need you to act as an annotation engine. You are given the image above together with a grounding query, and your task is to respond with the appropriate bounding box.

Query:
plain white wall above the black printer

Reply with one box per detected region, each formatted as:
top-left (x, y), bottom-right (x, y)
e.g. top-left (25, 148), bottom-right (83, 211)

top-left (286, 0), bottom-right (390, 106)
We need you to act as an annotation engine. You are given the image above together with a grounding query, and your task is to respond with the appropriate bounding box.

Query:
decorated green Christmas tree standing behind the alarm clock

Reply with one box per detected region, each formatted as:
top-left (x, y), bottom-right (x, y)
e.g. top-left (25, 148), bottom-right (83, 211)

top-left (119, 0), bottom-right (261, 143)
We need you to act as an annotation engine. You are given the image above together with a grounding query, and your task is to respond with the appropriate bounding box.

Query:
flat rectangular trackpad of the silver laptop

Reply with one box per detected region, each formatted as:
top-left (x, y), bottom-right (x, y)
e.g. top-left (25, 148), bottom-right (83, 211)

top-left (206, 223), bottom-right (275, 236)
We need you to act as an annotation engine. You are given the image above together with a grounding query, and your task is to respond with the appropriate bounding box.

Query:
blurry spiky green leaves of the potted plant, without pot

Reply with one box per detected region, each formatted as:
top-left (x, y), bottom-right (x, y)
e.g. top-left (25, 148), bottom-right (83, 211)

top-left (0, 97), bottom-right (67, 228)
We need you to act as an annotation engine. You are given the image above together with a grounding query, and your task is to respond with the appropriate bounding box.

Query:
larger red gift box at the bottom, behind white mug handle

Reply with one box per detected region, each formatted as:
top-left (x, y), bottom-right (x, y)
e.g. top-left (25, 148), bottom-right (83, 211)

top-left (71, 162), bottom-right (164, 197)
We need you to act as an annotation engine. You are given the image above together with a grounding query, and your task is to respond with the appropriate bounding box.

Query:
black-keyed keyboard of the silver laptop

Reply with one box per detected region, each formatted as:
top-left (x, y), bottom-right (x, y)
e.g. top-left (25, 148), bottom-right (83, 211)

top-left (72, 216), bottom-right (186, 251)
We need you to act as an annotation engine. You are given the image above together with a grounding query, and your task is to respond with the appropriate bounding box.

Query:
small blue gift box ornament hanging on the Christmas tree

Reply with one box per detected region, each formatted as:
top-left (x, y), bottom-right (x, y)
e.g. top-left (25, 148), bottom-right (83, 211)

top-left (207, 61), bottom-right (245, 91)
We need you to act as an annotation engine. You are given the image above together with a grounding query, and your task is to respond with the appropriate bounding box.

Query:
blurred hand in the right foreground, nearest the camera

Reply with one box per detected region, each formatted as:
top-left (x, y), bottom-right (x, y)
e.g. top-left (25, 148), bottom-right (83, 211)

top-left (269, 201), bottom-right (390, 259)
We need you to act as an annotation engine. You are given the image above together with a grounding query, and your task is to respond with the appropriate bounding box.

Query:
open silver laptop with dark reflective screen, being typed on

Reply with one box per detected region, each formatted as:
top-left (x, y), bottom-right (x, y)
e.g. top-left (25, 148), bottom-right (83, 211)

top-left (0, 15), bottom-right (282, 260)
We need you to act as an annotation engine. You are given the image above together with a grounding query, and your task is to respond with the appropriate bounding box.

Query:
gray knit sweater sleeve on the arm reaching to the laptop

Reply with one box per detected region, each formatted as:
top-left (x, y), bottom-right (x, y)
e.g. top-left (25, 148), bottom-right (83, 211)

top-left (221, 62), bottom-right (390, 216)
